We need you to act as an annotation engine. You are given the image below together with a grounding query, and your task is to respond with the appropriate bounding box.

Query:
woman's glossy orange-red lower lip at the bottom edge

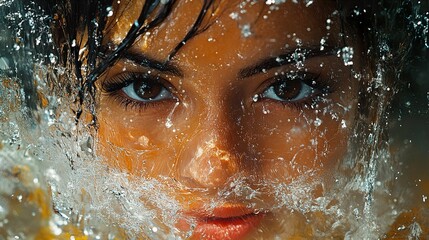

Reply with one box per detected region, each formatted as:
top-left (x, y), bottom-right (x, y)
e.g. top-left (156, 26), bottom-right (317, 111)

top-left (192, 213), bottom-right (264, 240)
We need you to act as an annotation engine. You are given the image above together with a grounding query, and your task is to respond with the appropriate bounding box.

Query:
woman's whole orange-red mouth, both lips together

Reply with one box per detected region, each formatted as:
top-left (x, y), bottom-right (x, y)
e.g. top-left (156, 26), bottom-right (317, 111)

top-left (180, 205), bottom-right (265, 240)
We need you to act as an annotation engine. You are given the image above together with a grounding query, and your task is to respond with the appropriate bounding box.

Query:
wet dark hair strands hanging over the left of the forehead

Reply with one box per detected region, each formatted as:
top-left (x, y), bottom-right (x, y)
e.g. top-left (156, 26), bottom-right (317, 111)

top-left (44, 0), bottom-right (217, 119)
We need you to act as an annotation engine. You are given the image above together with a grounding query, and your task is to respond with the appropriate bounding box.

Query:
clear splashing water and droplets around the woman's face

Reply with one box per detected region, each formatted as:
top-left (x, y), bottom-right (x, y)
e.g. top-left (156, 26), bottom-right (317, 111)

top-left (0, 1), bottom-right (429, 239)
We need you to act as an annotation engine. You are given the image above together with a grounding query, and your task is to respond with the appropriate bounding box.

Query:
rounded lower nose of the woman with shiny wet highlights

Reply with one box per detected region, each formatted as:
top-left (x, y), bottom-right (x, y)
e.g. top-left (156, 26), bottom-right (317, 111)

top-left (174, 121), bottom-right (240, 188)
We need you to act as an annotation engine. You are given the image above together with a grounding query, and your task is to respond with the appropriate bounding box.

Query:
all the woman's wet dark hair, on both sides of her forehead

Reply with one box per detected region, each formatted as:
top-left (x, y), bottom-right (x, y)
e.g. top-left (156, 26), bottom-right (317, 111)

top-left (40, 0), bottom-right (422, 134)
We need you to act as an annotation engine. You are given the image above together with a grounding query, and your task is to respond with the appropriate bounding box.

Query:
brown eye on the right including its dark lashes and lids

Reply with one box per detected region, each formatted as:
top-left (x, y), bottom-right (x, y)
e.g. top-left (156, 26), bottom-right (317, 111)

top-left (258, 73), bottom-right (330, 107)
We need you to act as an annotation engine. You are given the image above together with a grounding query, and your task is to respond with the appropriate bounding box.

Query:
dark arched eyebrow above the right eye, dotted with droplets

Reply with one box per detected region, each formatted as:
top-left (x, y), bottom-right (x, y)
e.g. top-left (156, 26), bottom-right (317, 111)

top-left (238, 46), bottom-right (338, 79)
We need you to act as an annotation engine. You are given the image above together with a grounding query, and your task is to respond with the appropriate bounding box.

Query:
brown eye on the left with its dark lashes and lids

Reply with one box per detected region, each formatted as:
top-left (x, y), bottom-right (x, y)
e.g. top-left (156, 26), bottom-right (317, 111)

top-left (102, 72), bottom-right (177, 107)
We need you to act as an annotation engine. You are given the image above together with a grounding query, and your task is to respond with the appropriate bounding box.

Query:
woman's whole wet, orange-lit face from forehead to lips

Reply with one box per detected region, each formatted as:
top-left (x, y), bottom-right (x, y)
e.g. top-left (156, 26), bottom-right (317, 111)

top-left (97, 1), bottom-right (360, 239)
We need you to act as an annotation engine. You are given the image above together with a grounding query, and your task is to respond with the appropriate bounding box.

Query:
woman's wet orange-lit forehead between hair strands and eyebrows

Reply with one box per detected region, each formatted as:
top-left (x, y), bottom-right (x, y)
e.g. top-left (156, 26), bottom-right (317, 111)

top-left (107, 0), bottom-right (340, 61)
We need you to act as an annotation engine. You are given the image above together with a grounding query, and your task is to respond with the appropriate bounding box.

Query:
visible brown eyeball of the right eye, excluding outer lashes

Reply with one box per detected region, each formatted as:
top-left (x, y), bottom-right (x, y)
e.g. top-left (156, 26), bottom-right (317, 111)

top-left (260, 76), bottom-right (320, 103)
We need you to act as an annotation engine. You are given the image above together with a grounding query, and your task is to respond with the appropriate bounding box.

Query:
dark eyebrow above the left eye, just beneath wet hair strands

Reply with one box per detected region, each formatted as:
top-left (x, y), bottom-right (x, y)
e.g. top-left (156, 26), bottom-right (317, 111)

top-left (121, 50), bottom-right (184, 77)
